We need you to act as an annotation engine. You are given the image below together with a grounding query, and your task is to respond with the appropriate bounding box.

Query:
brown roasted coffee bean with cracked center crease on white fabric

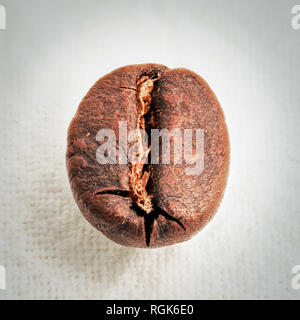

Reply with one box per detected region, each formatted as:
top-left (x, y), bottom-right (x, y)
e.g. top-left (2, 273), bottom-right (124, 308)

top-left (66, 64), bottom-right (229, 248)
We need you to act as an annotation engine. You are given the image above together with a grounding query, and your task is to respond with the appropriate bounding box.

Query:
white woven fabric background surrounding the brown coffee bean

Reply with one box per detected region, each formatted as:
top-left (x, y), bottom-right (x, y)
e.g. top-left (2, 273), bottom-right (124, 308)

top-left (0, 0), bottom-right (300, 299)
